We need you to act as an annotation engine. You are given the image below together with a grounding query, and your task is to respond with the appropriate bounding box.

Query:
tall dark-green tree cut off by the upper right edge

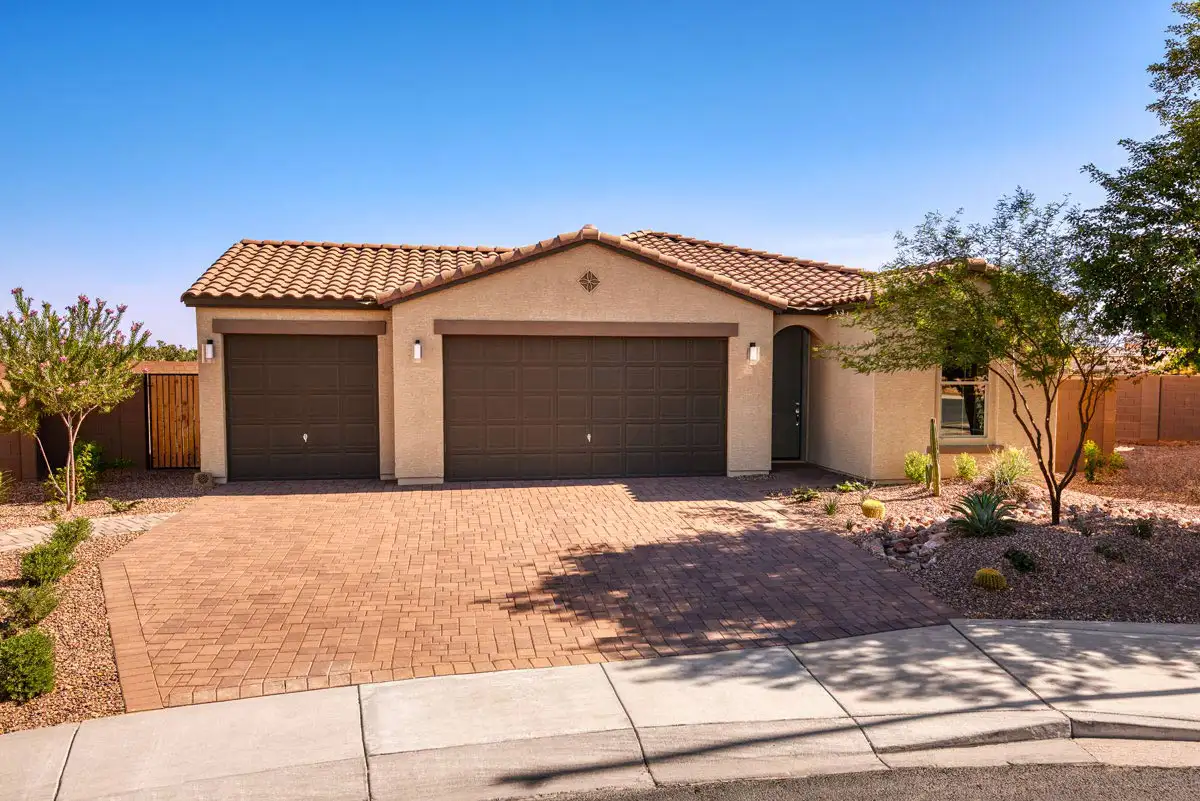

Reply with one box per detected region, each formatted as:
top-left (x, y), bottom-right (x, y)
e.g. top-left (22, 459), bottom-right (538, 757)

top-left (1078, 0), bottom-right (1200, 365)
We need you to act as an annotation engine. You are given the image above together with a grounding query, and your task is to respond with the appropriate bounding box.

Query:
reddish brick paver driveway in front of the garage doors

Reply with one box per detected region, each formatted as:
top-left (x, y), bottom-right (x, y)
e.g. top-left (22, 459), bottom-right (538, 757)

top-left (103, 478), bottom-right (949, 707)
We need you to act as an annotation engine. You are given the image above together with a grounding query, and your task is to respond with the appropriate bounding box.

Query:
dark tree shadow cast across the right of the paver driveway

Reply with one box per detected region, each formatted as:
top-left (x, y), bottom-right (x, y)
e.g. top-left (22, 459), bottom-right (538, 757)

top-left (490, 522), bottom-right (952, 658)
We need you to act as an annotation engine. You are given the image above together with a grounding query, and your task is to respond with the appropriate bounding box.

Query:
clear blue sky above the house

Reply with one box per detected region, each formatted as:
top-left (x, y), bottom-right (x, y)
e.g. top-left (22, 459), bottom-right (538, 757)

top-left (0, 0), bottom-right (1171, 343)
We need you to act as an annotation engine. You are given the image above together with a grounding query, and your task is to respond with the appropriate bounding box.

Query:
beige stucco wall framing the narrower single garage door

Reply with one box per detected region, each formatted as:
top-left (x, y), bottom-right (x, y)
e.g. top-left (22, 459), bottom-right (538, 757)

top-left (196, 307), bottom-right (396, 481)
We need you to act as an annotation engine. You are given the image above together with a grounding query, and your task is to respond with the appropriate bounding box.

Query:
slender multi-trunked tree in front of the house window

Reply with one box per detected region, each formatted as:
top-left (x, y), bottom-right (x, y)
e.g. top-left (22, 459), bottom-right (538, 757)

top-left (824, 189), bottom-right (1117, 523)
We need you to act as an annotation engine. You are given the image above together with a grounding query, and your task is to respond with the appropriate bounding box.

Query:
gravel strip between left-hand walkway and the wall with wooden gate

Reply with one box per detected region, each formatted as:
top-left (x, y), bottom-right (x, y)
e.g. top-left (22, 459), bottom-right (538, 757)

top-left (0, 470), bottom-right (202, 531)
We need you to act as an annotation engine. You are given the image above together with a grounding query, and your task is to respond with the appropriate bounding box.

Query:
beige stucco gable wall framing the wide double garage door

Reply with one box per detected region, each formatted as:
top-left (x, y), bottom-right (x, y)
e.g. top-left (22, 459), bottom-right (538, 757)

top-left (391, 242), bottom-right (774, 482)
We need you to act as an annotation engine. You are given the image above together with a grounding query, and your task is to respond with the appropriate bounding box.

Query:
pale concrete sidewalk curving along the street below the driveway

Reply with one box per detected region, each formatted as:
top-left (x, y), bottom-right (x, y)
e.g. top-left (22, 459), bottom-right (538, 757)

top-left (0, 621), bottom-right (1200, 801)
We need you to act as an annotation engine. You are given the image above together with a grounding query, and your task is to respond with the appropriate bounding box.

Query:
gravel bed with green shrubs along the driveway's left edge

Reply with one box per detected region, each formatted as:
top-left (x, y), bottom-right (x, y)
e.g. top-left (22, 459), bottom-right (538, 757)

top-left (0, 532), bottom-right (140, 733)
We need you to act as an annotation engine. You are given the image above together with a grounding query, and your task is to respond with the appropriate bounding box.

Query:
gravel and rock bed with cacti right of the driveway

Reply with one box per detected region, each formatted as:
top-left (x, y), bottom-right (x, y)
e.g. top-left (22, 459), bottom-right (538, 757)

top-left (772, 448), bottom-right (1200, 624)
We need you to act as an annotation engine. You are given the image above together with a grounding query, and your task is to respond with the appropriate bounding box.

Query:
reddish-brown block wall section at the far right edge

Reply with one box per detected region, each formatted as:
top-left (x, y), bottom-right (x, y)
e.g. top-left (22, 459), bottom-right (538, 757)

top-left (1116, 375), bottom-right (1200, 442)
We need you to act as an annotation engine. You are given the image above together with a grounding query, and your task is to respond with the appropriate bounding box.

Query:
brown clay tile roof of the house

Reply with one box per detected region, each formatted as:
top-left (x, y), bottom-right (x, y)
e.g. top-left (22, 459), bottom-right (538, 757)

top-left (182, 224), bottom-right (866, 311)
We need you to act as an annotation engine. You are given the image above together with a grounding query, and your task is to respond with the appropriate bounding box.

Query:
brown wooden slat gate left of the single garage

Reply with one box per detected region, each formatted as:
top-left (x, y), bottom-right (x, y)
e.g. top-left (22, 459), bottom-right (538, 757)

top-left (145, 374), bottom-right (200, 468)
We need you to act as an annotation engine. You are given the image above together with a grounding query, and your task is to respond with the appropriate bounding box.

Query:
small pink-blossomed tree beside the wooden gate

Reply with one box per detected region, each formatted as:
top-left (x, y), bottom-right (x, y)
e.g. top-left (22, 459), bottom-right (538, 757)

top-left (0, 288), bottom-right (150, 510)
